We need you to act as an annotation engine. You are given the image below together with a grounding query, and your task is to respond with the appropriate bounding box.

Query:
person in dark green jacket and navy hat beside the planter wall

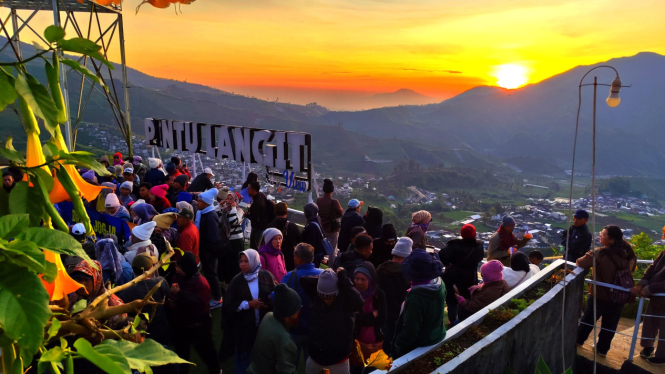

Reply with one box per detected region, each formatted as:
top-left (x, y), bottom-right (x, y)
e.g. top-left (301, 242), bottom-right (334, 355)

top-left (393, 249), bottom-right (446, 358)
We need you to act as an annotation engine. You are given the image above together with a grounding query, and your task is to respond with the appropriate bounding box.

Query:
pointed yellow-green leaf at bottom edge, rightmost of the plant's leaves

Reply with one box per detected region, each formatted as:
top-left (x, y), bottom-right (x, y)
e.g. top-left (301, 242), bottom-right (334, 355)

top-left (99, 339), bottom-right (191, 371)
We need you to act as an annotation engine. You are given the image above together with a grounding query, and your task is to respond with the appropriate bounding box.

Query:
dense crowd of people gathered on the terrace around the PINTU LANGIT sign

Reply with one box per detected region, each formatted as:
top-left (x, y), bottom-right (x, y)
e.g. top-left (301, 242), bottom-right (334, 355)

top-left (0, 153), bottom-right (665, 374)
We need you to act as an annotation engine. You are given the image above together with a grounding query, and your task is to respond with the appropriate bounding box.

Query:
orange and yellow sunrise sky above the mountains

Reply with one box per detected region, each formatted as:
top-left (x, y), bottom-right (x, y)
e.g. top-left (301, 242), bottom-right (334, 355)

top-left (0, 0), bottom-right (665, 106)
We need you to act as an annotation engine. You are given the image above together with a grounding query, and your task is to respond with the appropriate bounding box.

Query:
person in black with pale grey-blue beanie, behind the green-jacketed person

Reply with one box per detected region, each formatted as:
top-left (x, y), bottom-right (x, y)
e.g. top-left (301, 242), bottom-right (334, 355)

top-left (376, 237), bottom-right (413, 355)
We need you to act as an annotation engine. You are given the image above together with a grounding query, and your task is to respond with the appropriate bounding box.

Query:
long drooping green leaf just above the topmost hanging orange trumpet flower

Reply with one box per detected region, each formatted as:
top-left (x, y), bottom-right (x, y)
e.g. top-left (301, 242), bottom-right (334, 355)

top-left (14, 72), bottom-right (58, 134)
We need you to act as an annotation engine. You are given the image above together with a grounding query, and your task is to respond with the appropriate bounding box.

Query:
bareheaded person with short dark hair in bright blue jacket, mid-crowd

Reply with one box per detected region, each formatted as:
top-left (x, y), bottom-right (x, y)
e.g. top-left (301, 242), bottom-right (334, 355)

top-left (280, 243), bottom-right (323, 367)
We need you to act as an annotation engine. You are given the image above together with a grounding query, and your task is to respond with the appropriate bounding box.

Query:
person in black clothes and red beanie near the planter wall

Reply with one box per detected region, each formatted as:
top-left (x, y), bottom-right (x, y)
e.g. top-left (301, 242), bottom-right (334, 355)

top-left (439, 224), bottom-right (485, 325)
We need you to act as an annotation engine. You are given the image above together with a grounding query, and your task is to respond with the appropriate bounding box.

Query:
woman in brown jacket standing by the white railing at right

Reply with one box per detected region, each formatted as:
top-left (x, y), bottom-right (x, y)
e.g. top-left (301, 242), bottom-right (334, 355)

top-left (576, 225), bottom-right (637, 357)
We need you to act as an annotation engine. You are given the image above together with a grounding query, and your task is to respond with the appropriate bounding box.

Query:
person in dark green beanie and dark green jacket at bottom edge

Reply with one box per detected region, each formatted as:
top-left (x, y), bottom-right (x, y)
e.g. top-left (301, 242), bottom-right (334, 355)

top-left (247, 284), bottom-right (302, 374)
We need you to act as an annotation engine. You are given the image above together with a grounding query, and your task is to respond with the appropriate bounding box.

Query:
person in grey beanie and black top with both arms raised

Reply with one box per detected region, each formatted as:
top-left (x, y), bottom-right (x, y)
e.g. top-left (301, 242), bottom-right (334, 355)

top-left (300, 268), bottom-right (364, 374)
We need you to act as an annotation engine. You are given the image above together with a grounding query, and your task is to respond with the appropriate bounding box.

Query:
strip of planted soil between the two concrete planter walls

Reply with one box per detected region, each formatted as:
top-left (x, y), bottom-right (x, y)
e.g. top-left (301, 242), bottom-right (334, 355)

top-left (403, 280), bottom-right (552, 374)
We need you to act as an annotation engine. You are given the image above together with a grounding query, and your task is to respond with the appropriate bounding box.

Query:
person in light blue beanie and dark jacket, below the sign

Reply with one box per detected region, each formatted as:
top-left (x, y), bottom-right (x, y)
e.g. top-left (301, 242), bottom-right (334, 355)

top-left (194, 188), bottom-right (222, 308)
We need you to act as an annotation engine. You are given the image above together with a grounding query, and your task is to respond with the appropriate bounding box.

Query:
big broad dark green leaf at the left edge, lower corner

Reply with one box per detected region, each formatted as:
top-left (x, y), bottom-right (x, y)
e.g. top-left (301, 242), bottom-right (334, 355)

top-left (0, 261), bottom-right (51, 354)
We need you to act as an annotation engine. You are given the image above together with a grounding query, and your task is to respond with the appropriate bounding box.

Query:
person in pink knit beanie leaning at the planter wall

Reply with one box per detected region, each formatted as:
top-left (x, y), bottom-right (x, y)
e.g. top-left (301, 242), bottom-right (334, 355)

top-left (455, 260), bottom-right (510, 322)
